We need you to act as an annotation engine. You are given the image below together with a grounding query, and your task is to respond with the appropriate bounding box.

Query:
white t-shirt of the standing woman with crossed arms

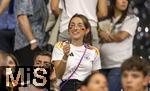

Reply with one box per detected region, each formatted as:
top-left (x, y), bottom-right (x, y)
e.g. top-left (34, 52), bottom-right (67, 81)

top-left (99, 15), bottom-right (139, 68)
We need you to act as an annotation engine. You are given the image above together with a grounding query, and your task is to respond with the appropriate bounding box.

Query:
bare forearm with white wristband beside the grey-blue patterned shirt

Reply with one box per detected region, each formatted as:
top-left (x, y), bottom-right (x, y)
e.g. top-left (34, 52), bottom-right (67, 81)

top-left (17, 15), bottom-right (37, 49)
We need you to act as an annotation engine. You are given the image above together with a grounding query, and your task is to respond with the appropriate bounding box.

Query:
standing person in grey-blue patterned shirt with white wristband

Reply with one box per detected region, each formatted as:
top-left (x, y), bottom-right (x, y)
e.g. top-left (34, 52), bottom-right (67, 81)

top-left (15, 0), bottom-right (48, 66)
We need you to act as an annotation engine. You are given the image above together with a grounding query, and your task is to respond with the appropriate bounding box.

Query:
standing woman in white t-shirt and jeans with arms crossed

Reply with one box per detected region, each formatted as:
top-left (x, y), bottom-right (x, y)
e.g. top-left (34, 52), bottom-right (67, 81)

top-left (99, 0), bottom-right (139, 91)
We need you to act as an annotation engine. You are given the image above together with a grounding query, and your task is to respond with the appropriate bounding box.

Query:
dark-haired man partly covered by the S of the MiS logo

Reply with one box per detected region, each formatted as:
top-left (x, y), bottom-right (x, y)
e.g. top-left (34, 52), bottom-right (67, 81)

top-left (19, 51), bottom-right (52, 91)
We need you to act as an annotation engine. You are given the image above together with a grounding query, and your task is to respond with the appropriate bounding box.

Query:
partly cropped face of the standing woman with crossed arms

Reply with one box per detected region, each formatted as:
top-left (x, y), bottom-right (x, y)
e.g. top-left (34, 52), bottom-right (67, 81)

top-left (116, 0), bottom-right (128, 11)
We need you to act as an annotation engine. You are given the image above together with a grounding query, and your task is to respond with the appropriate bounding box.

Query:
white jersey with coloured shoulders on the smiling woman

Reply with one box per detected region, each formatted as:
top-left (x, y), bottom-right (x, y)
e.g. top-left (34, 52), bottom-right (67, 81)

top-left (52, 42), bottom-right (101, 81)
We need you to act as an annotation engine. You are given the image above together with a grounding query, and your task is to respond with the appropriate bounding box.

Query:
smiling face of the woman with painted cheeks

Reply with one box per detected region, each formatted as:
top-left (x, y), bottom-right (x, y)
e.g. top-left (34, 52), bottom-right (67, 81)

top-left (69, 17), bottom-right (88, 40)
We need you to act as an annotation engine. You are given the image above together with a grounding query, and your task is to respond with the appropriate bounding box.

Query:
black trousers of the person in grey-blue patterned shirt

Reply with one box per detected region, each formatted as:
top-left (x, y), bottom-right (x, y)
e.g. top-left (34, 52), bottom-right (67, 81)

top-left (14, 45), bottom-right (41, 66)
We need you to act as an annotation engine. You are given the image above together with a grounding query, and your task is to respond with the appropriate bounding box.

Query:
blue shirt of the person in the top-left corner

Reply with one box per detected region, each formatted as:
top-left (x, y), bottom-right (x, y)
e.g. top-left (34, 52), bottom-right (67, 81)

top-left (0, 0), bottom-right (16, 30)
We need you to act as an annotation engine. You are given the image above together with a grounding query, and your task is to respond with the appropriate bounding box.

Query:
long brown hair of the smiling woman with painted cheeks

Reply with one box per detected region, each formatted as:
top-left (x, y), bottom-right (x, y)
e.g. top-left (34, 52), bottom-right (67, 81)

top-left (68, 14), bottom-right (92, 45)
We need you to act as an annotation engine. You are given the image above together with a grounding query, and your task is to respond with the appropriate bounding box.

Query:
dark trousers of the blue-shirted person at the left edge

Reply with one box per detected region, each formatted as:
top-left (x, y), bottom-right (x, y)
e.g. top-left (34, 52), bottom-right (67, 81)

top-left (0, 29), bottom-right (15, 53)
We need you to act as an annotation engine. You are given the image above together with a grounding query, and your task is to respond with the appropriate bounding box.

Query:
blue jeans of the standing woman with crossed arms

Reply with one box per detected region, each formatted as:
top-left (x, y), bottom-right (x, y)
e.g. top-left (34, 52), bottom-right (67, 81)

top-left (101, 68), bottom-right (121, 91)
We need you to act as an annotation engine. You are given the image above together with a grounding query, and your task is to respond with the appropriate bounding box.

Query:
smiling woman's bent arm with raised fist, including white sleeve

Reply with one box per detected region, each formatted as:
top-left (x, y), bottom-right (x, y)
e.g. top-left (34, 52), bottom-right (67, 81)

top-left (52, 43), bottom-right (70, 78)
